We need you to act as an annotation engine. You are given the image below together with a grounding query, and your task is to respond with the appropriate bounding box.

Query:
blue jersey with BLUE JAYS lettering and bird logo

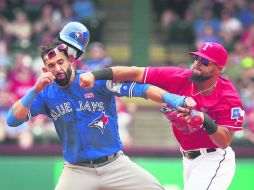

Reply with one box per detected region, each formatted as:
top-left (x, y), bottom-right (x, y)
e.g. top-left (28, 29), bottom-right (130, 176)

top-left (29, 71), bottom-right (143, 163)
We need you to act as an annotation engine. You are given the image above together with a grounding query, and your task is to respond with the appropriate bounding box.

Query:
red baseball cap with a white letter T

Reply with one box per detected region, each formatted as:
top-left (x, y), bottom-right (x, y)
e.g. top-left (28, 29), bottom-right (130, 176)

top-left (189, 42), bottom-right (228, 66)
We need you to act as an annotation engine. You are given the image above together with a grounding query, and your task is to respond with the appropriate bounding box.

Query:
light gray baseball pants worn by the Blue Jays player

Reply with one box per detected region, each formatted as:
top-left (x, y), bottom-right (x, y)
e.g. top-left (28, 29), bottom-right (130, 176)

top-left (55, 155), bottom-right (164, 190)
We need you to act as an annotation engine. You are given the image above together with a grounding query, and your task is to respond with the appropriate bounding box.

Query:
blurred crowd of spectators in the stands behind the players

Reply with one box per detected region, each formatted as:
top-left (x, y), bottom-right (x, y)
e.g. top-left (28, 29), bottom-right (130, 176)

top-left (0, 0), bottom-right (254, 148)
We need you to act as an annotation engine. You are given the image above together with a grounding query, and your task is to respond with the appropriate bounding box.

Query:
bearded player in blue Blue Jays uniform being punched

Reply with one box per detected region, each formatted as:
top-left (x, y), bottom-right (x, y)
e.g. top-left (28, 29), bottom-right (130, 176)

top-left (7, 22), bottom-right (196, 190)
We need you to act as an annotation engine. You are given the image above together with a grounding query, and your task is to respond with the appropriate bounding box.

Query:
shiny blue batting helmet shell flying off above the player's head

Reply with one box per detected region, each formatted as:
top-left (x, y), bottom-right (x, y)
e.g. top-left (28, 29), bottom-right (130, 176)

top-left (59, 22), bottom-right (90, 52)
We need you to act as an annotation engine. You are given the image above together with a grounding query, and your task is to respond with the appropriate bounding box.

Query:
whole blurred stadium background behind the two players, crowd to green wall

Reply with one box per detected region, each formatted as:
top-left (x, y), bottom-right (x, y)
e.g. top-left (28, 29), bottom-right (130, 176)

top-left (0, 0), bottom-right (254, 190)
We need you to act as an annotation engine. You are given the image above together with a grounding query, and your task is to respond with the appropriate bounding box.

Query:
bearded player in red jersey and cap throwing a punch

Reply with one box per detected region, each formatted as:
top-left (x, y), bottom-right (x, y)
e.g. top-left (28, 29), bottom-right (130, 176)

top-left (80, 42), bottom-right (245, 190)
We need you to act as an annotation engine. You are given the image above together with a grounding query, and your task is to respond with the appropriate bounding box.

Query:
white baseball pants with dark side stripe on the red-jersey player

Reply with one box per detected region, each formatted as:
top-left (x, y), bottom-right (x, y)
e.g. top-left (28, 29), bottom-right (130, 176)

top-left (183, 147), bottom-right (235, 190)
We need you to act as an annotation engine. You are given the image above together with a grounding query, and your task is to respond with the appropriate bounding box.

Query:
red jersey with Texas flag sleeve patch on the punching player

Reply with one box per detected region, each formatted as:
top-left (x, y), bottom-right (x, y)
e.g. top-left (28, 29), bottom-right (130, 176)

top-left (143, 67), bottom-right (244, 150)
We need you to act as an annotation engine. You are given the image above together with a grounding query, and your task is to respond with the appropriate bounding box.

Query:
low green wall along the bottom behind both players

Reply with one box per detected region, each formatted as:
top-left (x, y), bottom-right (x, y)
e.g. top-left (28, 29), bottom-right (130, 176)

top-left (0, 156), bottom-right (254, 190)
